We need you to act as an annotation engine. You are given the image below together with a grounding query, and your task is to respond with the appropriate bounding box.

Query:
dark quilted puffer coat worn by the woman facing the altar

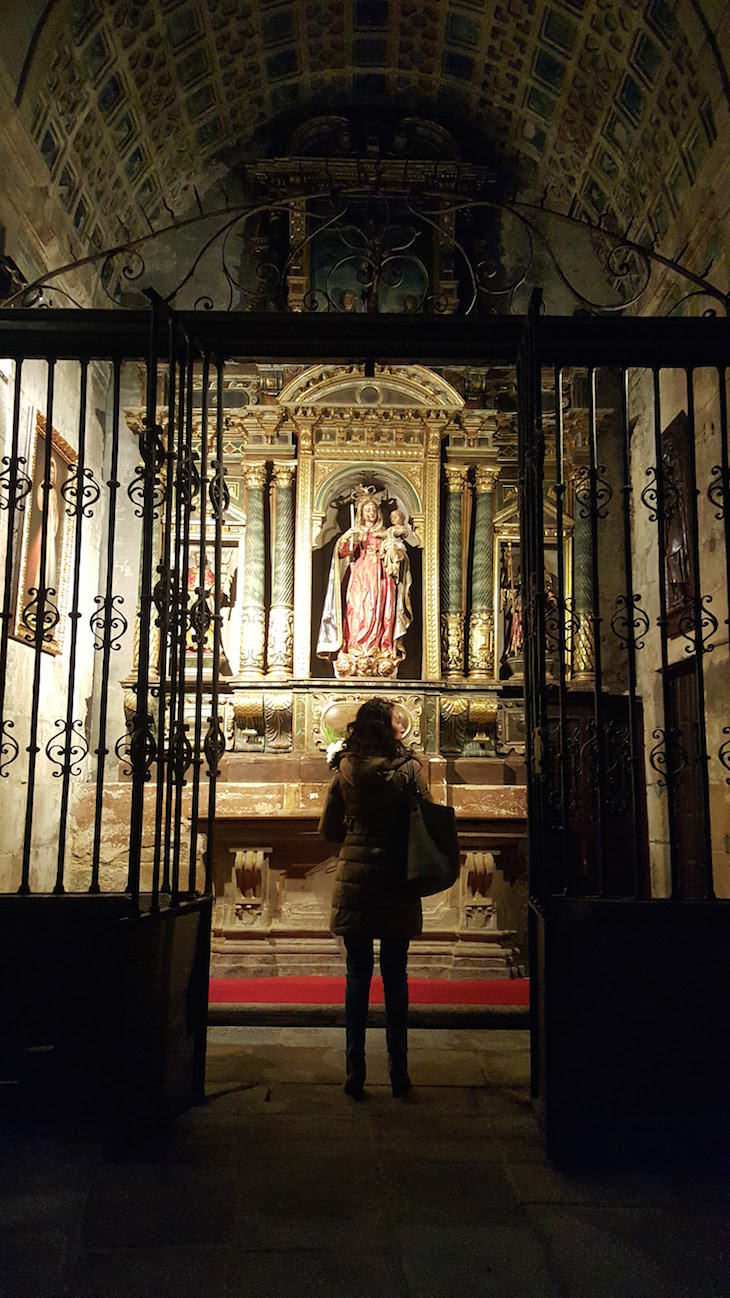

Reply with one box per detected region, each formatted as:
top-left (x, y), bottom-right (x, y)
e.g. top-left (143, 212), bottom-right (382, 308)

top-left (320, 755), bottom-right (429, 937)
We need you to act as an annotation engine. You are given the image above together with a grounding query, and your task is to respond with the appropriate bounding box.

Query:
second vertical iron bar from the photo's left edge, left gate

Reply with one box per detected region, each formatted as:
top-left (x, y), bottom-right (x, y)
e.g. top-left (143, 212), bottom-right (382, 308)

top-left (21, 360), bottom-right (55, 893)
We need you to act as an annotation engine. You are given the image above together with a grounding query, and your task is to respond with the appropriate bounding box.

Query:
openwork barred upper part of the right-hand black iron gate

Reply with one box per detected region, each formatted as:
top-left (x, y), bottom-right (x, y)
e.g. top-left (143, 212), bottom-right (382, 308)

top-left (518, 296), bottom-right (730, 903)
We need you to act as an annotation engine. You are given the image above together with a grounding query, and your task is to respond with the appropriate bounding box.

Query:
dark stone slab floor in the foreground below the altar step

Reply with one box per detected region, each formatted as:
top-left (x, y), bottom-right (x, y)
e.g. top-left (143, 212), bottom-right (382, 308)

top-left (0, 1027), bottom-right (730, 1298)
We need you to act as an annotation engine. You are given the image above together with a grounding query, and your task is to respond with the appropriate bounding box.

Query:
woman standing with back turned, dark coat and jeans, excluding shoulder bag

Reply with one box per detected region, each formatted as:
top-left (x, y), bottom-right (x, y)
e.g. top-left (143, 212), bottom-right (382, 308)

top-left (320, 698), bottom-right (429, 1099)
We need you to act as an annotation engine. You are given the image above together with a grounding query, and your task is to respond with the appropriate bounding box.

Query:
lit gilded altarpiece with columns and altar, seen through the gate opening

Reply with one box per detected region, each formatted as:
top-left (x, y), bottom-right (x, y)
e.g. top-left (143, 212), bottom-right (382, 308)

top-left (127, 365), bottom-right (535, 977)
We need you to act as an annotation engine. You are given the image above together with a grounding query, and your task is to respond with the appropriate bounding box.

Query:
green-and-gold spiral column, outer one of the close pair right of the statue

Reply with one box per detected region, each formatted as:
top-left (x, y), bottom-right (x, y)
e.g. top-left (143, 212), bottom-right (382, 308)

top-left (469, 465), bottom-right (499, 680)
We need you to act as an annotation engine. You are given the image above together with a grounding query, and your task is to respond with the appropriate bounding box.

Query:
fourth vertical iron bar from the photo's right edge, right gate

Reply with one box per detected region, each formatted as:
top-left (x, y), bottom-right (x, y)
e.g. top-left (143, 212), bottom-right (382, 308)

top-left (621, 370), bottom-right (643, 898)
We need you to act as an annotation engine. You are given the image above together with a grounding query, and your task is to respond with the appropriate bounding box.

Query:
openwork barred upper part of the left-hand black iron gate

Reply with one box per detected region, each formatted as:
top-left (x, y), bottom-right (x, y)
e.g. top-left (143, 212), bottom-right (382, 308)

top-left (0, 297), bottom-right (227, 911)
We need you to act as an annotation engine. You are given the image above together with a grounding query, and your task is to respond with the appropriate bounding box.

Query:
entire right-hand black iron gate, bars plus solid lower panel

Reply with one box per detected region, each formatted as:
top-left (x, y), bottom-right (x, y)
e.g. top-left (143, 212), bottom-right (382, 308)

top-left (518, 297), bottom-right (730, 1163)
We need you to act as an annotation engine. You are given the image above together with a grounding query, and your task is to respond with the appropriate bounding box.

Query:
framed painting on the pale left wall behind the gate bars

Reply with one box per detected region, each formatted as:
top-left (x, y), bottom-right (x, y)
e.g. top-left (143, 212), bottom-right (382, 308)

top-left (14, 414), bottom-right (77, 654)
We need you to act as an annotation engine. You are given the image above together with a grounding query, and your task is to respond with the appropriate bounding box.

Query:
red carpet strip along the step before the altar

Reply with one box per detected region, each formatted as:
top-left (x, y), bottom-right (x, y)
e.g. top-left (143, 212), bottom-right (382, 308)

top-left (210, 977), bottom-right (530, 1005)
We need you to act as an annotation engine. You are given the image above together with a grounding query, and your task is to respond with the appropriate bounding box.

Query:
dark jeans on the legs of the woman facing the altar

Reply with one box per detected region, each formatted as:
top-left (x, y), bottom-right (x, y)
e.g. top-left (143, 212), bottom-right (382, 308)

top-left (344, 937), bottom-right (408, 1075)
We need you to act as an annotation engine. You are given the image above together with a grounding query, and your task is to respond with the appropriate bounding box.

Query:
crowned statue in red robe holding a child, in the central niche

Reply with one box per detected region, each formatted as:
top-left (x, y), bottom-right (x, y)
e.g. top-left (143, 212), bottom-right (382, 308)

top-left (317, 495), bottom-right (413, 678)
